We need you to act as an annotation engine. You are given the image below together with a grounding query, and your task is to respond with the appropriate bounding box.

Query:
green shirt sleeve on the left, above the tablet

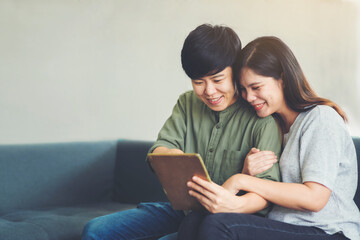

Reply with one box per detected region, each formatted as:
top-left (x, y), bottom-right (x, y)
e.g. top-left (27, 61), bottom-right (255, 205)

top-left (149, 95), bottom-right (186, 152)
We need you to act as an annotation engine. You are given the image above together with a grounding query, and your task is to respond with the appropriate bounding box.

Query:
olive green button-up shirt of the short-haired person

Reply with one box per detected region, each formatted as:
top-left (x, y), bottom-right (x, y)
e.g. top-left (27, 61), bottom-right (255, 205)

top-left (150, 91), bottom-right (281, 185)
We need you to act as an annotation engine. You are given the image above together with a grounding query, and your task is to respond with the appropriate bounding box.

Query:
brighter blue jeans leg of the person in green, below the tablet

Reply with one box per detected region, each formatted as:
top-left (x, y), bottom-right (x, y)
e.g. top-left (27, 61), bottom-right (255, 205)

top-left (81, 203), bottom-right (184, 240)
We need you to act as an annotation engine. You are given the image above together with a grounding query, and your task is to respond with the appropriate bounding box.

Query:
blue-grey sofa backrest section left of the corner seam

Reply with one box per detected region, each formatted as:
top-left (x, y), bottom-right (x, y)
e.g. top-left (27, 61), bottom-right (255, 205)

top-left (0, 141), bottom-right (117, 213)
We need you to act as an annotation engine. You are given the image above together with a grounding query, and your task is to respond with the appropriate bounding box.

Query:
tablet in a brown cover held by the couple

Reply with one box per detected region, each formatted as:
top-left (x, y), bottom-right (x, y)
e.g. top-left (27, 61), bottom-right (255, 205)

top-left (148, 153), bottom-right (211, 210)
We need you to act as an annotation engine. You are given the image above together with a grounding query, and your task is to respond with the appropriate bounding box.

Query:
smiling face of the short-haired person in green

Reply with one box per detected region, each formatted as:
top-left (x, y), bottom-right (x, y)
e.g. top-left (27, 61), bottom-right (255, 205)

top-left (192, 67), bottom-right (237, 111)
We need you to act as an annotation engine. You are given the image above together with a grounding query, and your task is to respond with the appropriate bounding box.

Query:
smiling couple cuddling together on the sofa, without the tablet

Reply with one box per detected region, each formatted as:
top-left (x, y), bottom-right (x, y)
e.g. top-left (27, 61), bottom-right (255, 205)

top-left (82, 24), bottom-right (360, 240)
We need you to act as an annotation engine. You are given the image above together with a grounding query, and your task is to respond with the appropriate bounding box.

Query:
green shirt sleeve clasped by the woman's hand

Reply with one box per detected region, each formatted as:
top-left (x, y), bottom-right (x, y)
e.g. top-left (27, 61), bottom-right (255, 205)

top-left (253, 116), bottom-right (281, 181)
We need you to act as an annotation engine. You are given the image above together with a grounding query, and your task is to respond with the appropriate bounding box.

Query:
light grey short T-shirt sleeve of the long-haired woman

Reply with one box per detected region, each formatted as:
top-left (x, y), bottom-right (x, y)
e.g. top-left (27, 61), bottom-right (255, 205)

top-left (299, 108), bottom-right (346, 189)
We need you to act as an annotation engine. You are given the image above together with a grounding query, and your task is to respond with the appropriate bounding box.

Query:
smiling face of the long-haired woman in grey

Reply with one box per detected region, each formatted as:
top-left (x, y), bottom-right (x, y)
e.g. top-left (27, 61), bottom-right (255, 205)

top-left (240, 67), bottom-right (288, 117)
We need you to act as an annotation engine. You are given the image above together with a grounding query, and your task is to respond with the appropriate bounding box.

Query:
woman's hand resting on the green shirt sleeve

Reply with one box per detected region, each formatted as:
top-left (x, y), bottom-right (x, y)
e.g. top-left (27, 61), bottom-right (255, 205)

top-left (242, 148), bottom-right (277, 176)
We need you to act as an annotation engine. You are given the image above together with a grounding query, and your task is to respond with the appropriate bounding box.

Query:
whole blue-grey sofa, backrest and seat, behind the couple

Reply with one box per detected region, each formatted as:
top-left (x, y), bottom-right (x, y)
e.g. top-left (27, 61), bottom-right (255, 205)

top-left (0, 138), bottom-right (360, 240)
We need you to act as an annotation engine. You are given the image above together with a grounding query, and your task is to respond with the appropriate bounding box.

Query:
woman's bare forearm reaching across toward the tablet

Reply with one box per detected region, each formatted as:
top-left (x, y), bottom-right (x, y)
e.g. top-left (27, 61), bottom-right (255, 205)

top-left (238, 175), bottom-right (331, 212)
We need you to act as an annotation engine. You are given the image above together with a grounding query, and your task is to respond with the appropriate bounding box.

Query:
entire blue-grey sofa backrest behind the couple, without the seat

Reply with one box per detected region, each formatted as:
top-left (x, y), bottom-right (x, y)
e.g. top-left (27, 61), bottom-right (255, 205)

top-left (0, 137), bottom-right (360, 214)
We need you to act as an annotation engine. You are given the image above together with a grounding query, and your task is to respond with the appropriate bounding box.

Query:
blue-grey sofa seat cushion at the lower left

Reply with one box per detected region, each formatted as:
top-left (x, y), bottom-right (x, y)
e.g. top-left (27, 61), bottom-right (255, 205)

top-left (0, 202), bottom-right (135, 240)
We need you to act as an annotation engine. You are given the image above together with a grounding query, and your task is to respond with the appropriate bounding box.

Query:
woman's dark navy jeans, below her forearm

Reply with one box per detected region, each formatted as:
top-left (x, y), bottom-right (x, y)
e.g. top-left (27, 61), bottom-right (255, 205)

top-left (178, 211), bottom-right (347, 240)
